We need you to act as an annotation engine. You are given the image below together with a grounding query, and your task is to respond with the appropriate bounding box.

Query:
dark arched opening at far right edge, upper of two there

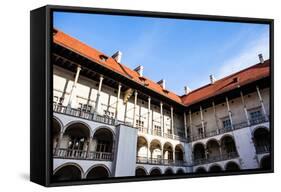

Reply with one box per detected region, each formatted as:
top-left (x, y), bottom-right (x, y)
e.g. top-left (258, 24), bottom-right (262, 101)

top-left (254, 127), bottom-right (270, 154)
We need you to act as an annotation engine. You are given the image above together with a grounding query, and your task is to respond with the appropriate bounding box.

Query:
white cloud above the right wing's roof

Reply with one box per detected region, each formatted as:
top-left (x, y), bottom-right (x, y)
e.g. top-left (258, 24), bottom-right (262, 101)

top-left (216, 32), bottom-right (269, 78)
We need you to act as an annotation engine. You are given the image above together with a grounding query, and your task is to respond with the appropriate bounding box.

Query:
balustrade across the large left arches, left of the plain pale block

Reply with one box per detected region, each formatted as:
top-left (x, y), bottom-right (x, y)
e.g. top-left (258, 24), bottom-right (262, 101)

top-left (53, 148), bottom-right (113, 161)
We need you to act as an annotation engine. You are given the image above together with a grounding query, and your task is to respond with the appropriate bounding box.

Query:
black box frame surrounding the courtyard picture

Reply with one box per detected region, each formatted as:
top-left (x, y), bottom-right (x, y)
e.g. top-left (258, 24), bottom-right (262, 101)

top-left (30, 5), bottom-right (274, 187)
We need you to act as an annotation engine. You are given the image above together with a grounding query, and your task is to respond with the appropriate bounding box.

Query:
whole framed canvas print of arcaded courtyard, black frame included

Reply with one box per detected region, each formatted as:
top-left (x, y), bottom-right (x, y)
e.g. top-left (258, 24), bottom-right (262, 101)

top-left (30, 5), bottom-right (274, 186)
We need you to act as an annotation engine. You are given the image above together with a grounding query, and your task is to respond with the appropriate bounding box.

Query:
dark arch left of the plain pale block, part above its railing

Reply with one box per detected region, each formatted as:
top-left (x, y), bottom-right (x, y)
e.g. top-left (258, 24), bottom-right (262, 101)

top-left (93, 127), bottom-right (114, 153)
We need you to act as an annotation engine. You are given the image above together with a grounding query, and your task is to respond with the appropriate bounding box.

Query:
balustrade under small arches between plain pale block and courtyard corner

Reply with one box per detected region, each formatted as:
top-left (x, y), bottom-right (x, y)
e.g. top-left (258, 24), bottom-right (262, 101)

top-left (137, 156), bottom-right (188, 166)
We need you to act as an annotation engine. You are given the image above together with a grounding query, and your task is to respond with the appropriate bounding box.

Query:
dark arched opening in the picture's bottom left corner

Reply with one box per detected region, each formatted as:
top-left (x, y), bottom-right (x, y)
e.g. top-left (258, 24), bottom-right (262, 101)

top-left (53, 165), bottom-right (82, 181)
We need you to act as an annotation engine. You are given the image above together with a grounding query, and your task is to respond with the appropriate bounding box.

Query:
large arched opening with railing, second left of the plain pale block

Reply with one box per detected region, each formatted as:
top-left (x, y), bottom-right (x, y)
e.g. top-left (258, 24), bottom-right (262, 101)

top-left (61, 123), bottom-right (90, 158)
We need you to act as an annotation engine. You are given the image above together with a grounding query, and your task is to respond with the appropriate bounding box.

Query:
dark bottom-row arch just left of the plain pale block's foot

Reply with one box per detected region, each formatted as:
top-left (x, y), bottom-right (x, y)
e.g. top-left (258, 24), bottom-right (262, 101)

top-left (85, 164), bottom-right (111, 179)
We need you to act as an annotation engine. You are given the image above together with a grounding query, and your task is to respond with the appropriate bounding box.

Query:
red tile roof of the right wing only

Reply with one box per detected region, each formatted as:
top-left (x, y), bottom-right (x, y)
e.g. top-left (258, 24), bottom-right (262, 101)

top-left (179, 60), bottom-right (270, 105)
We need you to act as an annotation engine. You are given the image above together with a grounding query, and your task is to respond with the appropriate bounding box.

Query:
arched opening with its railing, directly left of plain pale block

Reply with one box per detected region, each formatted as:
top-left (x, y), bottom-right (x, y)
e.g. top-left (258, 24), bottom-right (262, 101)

top-left (90, 128), bottom-right (114, 160)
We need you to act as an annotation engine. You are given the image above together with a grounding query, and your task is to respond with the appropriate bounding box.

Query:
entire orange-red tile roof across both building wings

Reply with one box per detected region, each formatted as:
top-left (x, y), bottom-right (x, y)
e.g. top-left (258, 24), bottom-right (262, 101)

top-left (53, 31), bottom-right (270, 106)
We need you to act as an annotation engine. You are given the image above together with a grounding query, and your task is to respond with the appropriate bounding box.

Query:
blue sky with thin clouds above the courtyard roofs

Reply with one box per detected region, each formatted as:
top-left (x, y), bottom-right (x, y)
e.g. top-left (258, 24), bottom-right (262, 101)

top-left (54, 12), bottom-right (269, 95)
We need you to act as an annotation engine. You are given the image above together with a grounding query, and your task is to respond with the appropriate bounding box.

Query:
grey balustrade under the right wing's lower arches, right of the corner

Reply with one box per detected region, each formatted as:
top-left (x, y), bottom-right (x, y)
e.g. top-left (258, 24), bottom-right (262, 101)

top-left (193, 152), bottom-right (239, 165)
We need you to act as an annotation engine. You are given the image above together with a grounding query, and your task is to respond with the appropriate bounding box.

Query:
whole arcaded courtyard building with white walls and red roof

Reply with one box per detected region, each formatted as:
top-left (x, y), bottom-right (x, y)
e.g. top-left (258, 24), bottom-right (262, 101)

top-left (52, 29), bottom-right (271, 181)
